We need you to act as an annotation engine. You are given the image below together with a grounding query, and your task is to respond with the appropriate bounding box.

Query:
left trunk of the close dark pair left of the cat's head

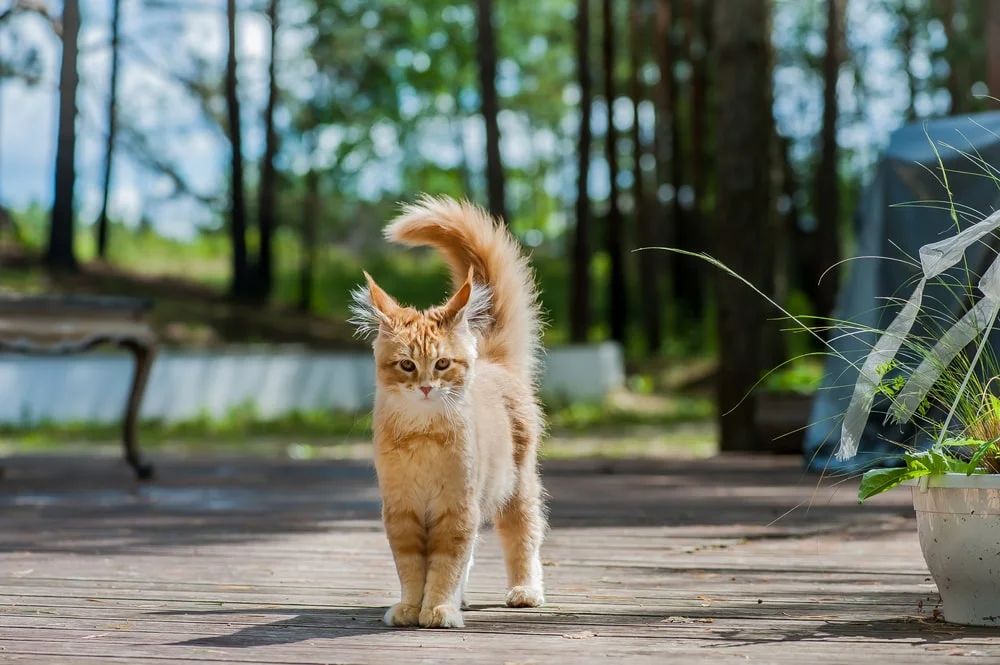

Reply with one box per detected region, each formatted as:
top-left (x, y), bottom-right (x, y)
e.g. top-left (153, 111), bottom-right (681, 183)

top-left (225, 0), bottom-right (251, 299)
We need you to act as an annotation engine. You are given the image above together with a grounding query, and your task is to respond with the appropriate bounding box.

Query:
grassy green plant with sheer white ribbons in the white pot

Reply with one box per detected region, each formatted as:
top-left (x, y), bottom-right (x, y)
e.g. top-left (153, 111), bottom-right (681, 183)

top-left (648, 126), bottom-right (1000, 501)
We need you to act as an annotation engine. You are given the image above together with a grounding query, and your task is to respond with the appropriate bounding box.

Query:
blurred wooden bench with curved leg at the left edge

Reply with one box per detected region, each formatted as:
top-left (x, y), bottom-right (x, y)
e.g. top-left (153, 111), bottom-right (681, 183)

top-left (0, 294), bottom-right (156, 480)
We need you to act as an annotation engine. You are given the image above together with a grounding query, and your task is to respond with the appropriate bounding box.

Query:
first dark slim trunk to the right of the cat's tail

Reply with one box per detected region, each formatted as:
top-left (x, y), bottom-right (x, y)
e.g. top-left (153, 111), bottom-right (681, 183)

top-left (570, 0), bottom-right (594, 344)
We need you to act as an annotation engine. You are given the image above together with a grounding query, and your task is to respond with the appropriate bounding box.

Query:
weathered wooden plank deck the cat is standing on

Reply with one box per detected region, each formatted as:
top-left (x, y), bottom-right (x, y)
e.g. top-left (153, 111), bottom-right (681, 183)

top-left (0, 448), bottom-right (1000, 665)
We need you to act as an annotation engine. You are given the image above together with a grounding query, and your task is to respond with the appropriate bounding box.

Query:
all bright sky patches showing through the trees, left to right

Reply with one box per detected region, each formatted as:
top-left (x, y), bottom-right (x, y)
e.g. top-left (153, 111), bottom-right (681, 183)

top-left (0, 0), bottom-right (947, 243)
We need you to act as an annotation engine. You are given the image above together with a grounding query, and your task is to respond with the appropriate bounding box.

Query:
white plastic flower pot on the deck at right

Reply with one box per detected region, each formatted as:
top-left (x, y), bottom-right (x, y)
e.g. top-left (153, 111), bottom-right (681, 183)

top-left (907, 473), bottom-right (1000, 626)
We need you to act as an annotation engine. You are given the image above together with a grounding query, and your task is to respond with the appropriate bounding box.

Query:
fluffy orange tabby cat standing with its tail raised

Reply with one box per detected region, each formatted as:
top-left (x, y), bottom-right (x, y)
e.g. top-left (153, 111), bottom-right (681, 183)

top-left (352, 197), bottom-right (545, 628)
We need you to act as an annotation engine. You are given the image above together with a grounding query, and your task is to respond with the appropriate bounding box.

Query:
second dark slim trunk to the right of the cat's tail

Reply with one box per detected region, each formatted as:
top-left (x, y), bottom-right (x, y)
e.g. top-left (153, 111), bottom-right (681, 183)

top-left (602, 0), bottom-right (628, 346)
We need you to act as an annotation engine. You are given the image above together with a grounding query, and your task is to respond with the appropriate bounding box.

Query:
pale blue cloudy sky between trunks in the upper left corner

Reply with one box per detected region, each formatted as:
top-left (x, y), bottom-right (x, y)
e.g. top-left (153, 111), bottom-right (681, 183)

top-left (0, 0), bottom-right (268, 237)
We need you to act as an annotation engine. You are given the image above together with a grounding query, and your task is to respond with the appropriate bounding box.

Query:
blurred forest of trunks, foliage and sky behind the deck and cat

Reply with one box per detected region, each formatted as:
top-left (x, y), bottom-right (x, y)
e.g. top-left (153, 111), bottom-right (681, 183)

top-left (0, 0), bottom-right (1000, 448)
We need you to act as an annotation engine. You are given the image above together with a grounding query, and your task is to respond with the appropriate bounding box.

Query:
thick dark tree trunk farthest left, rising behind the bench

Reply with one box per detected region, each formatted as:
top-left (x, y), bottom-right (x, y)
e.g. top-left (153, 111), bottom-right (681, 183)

top-left (45, 0), bottom-right (80, 270)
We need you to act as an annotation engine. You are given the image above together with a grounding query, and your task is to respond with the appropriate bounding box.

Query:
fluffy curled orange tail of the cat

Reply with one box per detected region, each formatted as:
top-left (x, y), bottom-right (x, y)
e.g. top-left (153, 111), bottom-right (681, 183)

top-left (385, 196), bottom-right (541, 382)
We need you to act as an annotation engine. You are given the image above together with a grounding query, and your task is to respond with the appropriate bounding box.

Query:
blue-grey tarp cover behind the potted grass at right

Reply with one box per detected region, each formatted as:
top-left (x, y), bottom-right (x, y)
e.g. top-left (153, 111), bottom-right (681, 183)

top-left (803, 112), bottom-right (1000, 471)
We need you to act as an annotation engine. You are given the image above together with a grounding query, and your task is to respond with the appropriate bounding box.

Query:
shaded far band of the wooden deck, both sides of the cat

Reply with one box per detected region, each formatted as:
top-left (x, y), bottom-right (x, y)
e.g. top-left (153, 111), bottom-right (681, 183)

top-left (0, 454), bottom-right (913, 554)
